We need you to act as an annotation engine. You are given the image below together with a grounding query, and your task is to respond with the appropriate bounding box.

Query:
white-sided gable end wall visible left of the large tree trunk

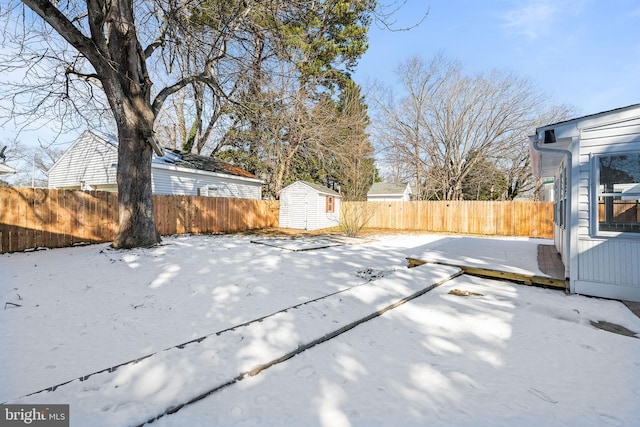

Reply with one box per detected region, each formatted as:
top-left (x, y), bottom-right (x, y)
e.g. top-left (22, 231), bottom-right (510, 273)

top-left (48, 132), bottom-right (118, 189)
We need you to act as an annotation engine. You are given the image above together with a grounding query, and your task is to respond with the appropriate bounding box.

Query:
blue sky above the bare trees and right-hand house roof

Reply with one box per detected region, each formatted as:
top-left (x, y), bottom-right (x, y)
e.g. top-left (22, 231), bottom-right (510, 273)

top-left (354, 0), bottom-right (640, 114)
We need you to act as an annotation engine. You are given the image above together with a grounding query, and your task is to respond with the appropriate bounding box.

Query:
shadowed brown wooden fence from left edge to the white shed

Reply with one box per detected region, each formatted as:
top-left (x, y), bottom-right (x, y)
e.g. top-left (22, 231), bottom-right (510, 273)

top-left (0, 188), bottom-right (279, 253)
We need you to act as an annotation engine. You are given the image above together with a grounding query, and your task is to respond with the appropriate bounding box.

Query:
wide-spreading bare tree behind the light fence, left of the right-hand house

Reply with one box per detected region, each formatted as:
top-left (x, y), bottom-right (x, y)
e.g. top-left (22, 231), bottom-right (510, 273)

top-left (376, 55), bottom-right (568, 200)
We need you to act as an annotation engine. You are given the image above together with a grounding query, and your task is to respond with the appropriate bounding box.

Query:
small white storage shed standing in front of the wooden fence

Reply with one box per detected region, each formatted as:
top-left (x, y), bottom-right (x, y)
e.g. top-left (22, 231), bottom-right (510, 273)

top-left (280, 181), bottom-right (342, 230)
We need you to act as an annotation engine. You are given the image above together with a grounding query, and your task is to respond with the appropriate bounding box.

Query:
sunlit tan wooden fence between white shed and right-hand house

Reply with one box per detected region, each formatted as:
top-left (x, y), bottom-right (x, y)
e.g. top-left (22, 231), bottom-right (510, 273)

top-left (342, 201), bottom-right (553, 239)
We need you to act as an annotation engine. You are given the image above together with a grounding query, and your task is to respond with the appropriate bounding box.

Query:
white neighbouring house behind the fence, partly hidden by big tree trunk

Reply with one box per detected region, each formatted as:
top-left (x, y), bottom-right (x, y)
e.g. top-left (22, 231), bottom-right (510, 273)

top-left (48, 131), bottom-right (263, 199)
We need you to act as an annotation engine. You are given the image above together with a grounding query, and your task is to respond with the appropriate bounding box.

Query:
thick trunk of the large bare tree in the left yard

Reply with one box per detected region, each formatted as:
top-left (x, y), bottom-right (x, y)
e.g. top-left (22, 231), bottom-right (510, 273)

top-left (96, 0), bottom-right (160, 248)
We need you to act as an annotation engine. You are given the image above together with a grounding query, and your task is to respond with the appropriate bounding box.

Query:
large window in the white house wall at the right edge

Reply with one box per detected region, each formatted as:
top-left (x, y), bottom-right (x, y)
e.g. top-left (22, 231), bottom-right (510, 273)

top-left (597, 152), bottom-right (640, 233)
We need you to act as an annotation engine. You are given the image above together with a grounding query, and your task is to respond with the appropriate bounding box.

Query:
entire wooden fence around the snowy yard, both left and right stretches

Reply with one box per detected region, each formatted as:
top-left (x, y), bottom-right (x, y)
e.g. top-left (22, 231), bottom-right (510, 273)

top-left (0, 188), bottom-right (553, 253)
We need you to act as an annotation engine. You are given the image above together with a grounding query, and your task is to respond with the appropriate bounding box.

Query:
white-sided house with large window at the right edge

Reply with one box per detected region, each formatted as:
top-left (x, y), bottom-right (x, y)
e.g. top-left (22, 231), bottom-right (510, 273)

top-left (531, 104), bottom-right (640, 301)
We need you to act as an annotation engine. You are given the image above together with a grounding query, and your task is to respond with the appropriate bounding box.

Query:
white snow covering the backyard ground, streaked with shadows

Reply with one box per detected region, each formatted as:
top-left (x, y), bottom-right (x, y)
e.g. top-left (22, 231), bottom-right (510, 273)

top-left (0, 234), bottom-right (640, 426)
